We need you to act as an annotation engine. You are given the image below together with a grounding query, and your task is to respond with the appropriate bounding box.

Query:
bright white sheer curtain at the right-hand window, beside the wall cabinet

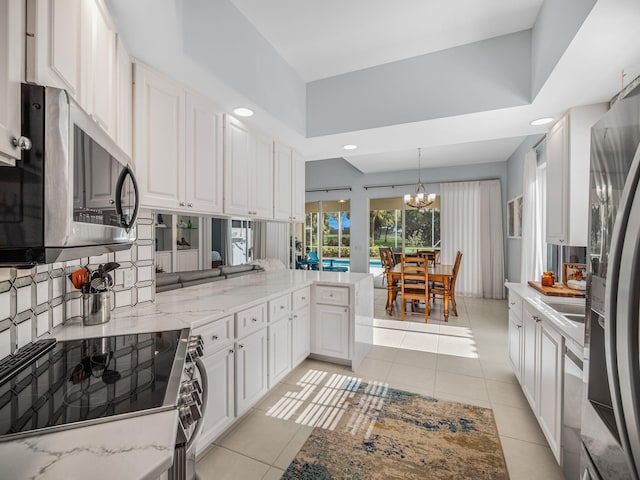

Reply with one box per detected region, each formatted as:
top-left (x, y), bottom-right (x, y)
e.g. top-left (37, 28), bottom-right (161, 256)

top-left (520, 150), bottom-right (547, 284)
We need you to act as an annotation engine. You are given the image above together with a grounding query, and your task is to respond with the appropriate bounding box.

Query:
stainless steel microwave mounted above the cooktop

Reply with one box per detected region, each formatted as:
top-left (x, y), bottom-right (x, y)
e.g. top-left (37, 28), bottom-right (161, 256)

top-left (0, 84), bottom-right (139, 267)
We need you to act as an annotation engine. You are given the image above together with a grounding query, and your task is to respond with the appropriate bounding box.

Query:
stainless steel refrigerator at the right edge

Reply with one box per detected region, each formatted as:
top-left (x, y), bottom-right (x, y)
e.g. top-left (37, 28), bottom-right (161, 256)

top-left (584, 80), bottom-right (640, 480)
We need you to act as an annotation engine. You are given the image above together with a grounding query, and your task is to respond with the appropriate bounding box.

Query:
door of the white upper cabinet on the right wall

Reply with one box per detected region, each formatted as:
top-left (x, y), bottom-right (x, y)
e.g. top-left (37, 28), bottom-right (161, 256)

top-left (546, 116), bottom-right (568, 244)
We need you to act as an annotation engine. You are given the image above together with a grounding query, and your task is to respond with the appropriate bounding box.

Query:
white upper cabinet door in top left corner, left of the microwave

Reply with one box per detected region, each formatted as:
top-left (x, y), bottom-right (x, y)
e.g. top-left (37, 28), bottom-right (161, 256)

top-left (0, 0), bottom-right (24, 166)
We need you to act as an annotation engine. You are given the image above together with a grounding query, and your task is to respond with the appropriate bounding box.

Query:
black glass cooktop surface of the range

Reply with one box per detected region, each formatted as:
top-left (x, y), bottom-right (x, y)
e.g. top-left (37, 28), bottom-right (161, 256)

top-left (0, 330), bottom-right (188, 441)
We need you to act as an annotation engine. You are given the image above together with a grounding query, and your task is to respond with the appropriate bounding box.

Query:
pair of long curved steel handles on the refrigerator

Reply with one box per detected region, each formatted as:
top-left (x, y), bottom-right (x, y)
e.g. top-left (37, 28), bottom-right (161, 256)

top-left (605, 142), bottom-right (640, 479)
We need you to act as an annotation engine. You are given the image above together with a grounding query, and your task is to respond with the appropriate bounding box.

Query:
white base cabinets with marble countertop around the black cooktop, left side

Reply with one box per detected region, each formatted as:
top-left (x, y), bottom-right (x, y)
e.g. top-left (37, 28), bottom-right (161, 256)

top-left (0, 270), bottom-right (373, 479)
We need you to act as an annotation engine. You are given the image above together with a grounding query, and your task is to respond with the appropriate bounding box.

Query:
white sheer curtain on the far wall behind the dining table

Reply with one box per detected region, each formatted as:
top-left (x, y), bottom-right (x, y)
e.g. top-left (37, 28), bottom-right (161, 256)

top-left (440, 180), bottom-right (504, 299)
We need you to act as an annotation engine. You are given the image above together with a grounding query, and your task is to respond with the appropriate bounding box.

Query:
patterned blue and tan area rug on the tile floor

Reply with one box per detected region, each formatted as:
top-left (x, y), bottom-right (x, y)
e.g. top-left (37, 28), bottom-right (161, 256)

top-left (282, 384), bottom-right (509, 480)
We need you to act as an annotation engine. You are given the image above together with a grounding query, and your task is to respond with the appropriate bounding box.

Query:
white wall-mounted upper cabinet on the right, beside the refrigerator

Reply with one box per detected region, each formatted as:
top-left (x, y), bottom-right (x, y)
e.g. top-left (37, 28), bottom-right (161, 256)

top-left (546, 104), bottom-right (606, 246)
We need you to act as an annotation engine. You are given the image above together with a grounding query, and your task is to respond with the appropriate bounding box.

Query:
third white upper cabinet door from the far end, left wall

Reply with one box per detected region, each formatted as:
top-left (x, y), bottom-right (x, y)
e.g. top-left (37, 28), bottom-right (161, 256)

top-left (249, 132), bottom-right (273, 219)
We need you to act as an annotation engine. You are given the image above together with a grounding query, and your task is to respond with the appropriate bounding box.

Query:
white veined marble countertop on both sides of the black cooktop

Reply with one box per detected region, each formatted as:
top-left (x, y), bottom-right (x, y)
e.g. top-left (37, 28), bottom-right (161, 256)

top-left (0, 270), bottom-right (371, 480)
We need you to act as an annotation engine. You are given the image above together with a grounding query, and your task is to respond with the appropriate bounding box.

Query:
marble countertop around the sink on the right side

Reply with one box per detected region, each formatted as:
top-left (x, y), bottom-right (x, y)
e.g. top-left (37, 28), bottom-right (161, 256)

top-left (505, 283), bottom-right (585, 348)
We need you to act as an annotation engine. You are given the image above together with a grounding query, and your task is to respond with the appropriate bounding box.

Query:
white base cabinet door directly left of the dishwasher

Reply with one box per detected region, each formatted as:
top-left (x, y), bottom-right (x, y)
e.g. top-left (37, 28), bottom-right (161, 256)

top-left (538, 324), bottom-right (564, 462)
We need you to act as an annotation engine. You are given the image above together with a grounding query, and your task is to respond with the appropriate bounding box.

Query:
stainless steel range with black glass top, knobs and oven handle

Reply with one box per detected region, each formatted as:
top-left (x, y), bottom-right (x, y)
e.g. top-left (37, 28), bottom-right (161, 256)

top-left (0, 329), bottom-right (207, 480)
